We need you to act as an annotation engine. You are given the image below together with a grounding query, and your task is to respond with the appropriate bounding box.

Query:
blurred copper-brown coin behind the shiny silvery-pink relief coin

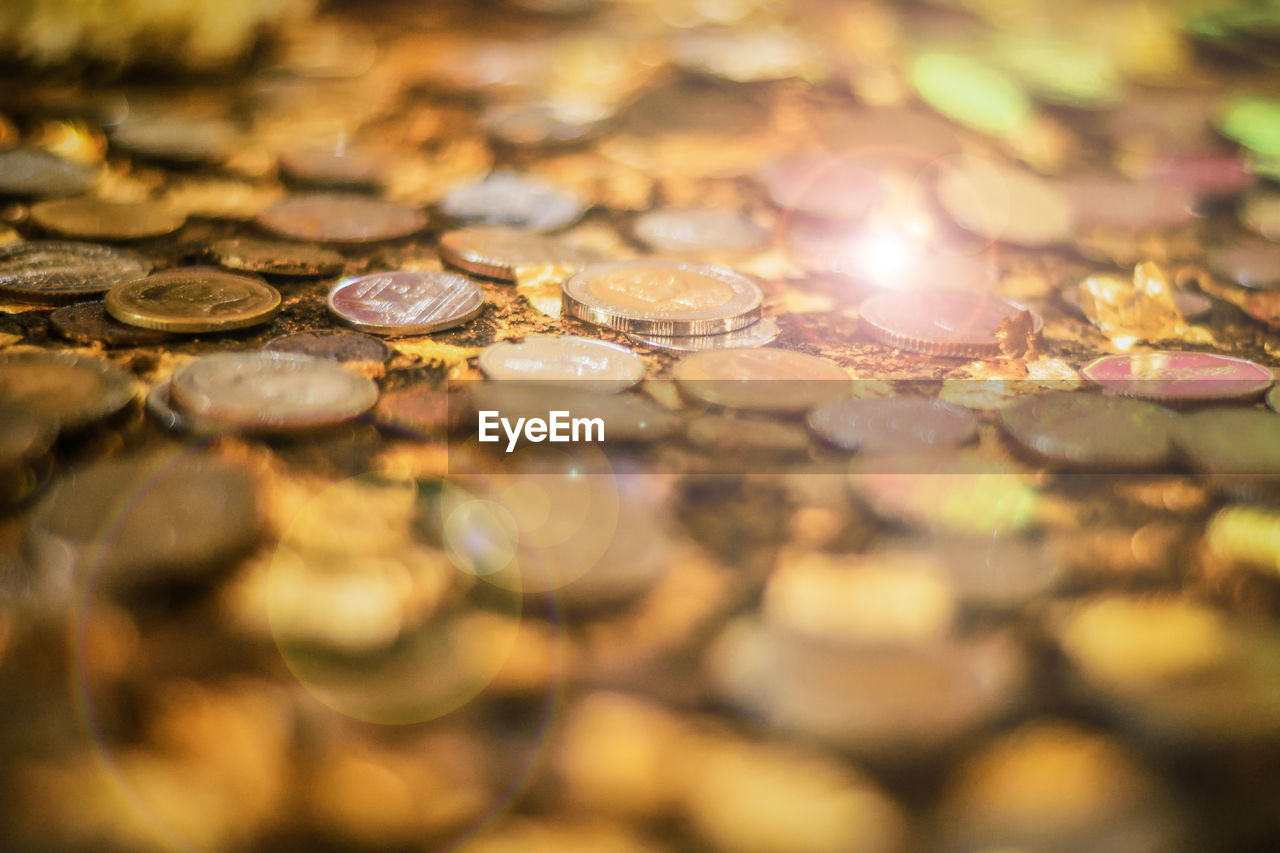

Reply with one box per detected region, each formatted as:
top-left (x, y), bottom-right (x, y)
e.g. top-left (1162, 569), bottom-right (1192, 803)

top-left (256, 193), bottom-right (426, 243)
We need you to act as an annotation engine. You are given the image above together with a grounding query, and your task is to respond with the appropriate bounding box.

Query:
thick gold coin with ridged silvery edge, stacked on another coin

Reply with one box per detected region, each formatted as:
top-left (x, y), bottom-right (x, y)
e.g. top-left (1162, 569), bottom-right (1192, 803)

top-left (563, 260), bottom-right (764, 337)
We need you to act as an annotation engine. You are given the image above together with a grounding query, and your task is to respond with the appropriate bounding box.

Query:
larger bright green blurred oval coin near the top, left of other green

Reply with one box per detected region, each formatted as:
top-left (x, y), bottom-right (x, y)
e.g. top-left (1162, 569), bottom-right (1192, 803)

top-left (910, 50), bottom-right (1032, 137)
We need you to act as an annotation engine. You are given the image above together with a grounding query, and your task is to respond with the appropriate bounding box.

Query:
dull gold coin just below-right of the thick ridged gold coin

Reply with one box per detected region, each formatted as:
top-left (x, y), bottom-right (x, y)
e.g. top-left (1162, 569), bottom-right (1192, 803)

top-left (673, 350), bottom-right (851, 412)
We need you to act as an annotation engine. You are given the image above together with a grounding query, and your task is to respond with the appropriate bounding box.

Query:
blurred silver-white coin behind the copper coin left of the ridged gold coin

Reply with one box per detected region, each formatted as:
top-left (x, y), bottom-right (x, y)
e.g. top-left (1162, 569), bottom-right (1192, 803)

top-left (440, 172), bottom-right (584, 231)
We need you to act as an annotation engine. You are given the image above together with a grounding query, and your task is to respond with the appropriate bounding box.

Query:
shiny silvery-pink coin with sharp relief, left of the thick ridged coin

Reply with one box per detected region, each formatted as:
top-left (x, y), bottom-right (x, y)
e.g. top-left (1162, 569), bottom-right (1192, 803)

top-left (329, 272), bottom-right (484, 336)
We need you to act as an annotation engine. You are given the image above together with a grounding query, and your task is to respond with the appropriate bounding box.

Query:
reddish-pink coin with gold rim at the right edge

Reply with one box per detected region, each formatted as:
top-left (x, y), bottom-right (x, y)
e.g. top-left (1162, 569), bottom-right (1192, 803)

top-left (1080, 351), bottom-right (1275, 403)
